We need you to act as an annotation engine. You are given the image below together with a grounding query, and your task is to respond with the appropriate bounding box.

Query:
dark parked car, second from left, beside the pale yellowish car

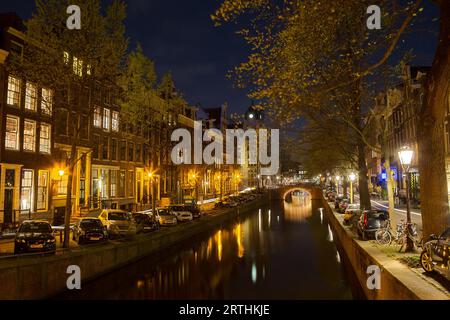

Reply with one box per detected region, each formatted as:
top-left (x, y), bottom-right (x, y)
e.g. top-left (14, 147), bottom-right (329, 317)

top-left (72, 218), bottom-right (108, 244)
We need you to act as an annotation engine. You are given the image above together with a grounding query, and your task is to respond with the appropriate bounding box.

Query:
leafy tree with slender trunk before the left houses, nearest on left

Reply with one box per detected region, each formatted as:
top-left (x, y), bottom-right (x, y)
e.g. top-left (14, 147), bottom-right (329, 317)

top-left (10, 0), bottom-right (127, 248)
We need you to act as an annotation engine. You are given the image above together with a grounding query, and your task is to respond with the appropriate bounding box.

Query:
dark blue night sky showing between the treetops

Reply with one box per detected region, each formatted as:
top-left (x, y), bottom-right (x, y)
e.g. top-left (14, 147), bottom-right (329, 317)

top-left (0, 0), bottom-right (437, 116)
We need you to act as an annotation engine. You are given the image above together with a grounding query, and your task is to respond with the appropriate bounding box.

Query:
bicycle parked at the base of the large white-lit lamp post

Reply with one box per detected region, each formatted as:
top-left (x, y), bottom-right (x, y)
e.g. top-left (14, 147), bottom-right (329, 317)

top-left (375, 220), bottom-right (423, 252)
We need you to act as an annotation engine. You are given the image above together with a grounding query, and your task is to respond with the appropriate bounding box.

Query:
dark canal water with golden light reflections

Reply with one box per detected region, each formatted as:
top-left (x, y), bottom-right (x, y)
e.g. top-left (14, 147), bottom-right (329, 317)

top-left (56, 198), bottom-right (353, 300)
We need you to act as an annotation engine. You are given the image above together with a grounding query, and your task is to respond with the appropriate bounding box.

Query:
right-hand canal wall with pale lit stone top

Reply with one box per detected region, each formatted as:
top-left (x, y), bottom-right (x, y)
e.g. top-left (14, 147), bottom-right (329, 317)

top-left (315, 190), bottom-right (450, 300)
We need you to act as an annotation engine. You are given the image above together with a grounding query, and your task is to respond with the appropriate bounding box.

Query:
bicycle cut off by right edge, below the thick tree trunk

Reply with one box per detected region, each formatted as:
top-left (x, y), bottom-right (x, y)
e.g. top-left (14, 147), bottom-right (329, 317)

top-left (420, 228), bottom-right (450, 280)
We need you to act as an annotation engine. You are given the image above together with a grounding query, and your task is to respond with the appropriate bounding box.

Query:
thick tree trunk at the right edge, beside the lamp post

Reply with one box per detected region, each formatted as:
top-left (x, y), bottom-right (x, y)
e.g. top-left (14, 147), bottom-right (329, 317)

top-left (417, 1), bottom-right (450, 238)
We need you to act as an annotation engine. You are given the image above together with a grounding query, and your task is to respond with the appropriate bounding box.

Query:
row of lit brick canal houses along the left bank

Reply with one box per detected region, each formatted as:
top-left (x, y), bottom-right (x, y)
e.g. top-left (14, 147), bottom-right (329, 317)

top-left (0, 14), bottom-right (241, 229)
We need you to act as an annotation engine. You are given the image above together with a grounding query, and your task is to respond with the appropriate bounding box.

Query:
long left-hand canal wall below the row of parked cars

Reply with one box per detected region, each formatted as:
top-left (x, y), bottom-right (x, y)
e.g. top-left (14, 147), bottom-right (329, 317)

top-left (0, 196), bottom-right (269, 300)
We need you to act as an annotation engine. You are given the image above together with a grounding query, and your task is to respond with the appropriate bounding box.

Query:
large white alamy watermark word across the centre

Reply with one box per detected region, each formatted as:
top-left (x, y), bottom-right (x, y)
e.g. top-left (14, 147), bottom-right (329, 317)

top-left (171, 121), bottom-right (280, 176)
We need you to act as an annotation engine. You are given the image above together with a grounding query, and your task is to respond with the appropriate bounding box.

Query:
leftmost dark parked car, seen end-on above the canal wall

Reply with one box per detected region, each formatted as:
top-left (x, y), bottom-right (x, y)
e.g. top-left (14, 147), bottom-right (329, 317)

top-left (14, 220), bottom-right (56, 254)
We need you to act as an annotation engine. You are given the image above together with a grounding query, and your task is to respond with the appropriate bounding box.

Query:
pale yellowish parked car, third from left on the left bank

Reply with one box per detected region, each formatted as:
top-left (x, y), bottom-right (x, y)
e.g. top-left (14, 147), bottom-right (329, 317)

top-left (99, 209), bottom-right (136, 238)
